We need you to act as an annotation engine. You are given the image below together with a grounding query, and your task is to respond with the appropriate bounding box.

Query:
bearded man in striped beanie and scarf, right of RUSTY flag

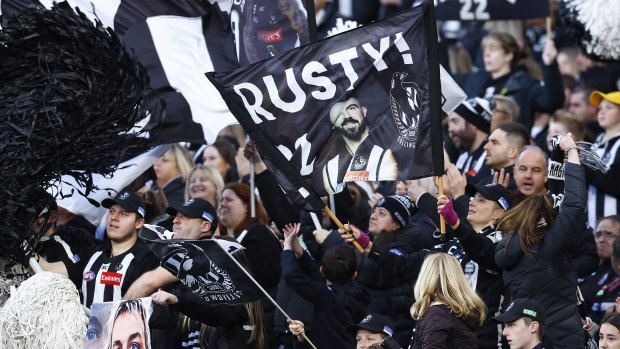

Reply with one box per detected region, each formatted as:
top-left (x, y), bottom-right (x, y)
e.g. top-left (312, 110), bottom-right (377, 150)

top-left (448, 97), bottom-right (495, 184)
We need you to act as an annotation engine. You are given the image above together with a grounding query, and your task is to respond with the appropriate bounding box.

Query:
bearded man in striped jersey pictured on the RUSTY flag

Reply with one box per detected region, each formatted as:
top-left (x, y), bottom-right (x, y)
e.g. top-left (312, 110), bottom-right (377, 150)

top-left (322, 98), bottom-right (398, 194)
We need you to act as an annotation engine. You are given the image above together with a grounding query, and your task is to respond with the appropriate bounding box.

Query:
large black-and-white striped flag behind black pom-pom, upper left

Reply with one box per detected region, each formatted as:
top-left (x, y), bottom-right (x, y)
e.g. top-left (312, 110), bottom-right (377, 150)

top-left (0, 0), bottom-right (239, 143)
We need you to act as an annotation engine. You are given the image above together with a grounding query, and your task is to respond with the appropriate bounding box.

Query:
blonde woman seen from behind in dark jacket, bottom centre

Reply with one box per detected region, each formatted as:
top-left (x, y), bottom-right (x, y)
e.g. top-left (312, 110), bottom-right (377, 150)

top-left (411, 253), bottom-right (485, 349)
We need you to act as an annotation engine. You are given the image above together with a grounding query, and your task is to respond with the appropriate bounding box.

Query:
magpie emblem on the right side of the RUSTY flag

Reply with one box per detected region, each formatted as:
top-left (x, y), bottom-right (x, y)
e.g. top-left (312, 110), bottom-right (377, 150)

top-left (390, 72), bottom-right (422, 149)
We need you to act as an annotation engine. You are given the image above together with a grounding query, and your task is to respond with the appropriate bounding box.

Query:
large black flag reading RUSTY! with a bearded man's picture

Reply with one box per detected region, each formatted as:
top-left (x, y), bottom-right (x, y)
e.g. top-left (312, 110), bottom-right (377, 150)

top-left (209, 2), bottom-right (464, 208)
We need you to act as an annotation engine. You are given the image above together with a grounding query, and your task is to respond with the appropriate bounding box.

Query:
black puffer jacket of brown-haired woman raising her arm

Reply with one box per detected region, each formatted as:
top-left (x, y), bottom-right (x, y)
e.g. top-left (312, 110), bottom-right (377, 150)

top-left (495, 163), bottom-right (587, 348)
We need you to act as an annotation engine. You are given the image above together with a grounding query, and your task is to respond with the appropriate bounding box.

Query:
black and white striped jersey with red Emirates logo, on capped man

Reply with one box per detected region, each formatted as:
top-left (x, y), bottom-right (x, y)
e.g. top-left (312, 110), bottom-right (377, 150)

top-left (64, 238), bottom-right (159, 307)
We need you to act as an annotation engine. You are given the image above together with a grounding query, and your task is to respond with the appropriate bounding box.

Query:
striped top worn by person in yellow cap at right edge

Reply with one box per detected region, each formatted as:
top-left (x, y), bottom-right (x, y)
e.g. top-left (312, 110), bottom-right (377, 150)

top-left (586, 133), bottom-right (620, 228)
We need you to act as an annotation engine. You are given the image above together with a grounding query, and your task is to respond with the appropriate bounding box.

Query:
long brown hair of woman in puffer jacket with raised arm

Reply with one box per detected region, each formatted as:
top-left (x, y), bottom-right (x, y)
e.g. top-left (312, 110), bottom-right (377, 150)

top-left (497, 195), bottom-right (558, 259)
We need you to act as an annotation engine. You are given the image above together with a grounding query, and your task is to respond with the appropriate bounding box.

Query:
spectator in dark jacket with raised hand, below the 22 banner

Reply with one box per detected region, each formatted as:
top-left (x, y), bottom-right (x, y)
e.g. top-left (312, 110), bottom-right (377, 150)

top-left (455, 33), bottom-right (564, 129)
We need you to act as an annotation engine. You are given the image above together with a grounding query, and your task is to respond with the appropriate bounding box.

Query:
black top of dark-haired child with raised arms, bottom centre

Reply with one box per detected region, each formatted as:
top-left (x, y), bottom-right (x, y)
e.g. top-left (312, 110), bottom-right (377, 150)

top-left (281, 250), bottom-right (369, 348)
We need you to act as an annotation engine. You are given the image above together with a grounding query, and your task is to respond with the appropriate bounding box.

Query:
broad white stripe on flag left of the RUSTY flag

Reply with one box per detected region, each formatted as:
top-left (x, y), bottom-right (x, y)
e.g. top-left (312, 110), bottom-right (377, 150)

top-left (147, 16), bottom-right (238, 143)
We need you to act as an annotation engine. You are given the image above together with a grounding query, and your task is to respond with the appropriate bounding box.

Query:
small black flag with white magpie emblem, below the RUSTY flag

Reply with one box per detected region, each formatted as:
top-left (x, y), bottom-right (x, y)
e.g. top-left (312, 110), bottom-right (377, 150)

top-left (143, 239), bottom-right (265, 304)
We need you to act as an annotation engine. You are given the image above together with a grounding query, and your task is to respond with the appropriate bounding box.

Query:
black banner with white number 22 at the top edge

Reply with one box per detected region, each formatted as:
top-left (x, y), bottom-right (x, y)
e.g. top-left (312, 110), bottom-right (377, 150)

top-left (435, 0), bottom-right (549, 21)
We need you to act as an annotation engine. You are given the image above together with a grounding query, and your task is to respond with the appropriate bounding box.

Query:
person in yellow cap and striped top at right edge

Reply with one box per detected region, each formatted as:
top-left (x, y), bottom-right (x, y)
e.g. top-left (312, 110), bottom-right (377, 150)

top-left (586, 91), bottom-right (620, 226)
